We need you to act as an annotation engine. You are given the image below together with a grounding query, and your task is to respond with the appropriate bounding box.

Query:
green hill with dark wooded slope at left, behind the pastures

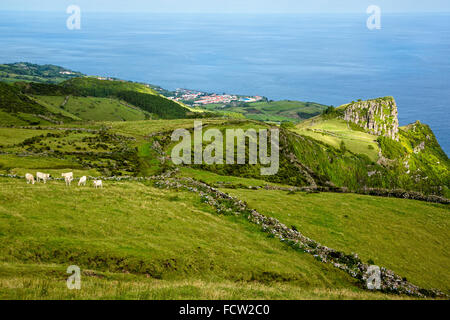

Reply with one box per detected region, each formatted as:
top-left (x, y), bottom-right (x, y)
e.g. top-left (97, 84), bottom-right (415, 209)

top-left (0, 78), bottom-right (199, 125)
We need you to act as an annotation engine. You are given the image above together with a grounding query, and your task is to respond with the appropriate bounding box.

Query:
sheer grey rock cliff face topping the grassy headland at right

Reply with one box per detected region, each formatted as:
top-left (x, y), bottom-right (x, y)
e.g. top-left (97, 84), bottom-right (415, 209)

top-left (344, 97), bottom-right (399, 141)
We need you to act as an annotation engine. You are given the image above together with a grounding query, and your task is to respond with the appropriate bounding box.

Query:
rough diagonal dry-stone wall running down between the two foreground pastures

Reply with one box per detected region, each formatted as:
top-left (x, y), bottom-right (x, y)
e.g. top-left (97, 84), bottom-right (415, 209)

top-left (156, 178), bottom-right (448, 298)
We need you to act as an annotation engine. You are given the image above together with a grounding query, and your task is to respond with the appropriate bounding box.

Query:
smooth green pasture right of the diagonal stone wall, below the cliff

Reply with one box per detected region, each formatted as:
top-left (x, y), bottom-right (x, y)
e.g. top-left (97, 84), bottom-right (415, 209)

top-left (223, 189), bottom-right (450, 292)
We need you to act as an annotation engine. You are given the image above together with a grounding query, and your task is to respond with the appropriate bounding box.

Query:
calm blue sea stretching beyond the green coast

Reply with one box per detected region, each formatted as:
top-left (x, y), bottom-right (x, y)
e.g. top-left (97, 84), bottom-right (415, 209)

top-left (0, 11), bottom-right (450, 154)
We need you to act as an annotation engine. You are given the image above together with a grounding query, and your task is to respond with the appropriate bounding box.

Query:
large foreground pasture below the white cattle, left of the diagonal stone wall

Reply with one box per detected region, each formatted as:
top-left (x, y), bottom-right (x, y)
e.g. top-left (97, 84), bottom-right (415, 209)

top-left (0, 178), bottom-right (395, 299)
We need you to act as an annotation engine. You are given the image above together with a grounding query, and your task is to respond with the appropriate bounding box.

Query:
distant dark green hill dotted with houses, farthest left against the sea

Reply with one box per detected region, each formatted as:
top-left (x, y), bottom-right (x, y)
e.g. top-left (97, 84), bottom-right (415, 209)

top-left (0, 62), bottom-right (83, 83)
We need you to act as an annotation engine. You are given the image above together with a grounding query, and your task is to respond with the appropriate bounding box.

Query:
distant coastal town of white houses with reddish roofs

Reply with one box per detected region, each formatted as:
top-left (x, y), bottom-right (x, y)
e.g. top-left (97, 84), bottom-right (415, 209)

top-left (168, 88), bottom-right (264, 106)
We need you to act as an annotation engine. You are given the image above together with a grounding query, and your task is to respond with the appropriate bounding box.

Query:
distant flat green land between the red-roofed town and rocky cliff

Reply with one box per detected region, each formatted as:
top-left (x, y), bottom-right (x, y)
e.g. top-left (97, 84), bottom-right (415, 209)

top-left (205, 100), bottom-right (327, 123)
